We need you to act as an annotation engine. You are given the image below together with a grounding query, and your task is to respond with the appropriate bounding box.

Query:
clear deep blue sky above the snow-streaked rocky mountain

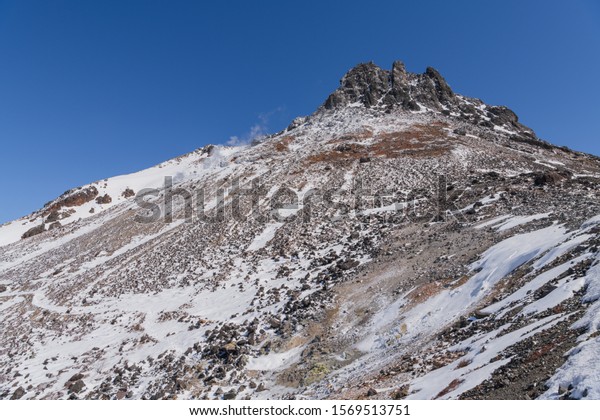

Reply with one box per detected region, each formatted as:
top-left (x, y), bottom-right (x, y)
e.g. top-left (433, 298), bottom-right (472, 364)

top-left (0, 0), bottom-right (600, 222)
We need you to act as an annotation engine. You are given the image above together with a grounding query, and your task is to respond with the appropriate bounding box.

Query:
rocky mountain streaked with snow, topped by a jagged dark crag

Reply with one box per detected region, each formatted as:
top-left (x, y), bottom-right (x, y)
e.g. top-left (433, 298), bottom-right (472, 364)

top-left (0, 62), bottom-right (600, 399)
